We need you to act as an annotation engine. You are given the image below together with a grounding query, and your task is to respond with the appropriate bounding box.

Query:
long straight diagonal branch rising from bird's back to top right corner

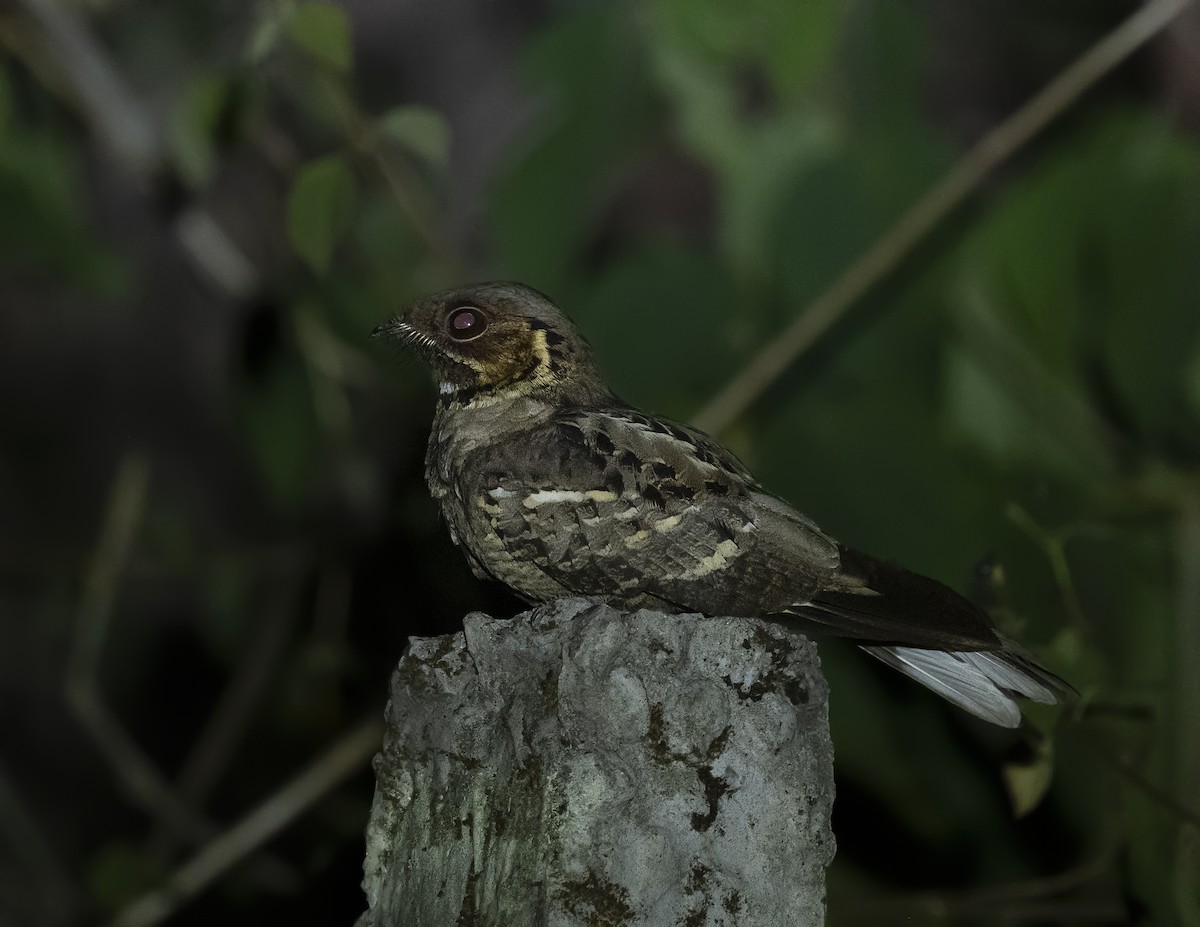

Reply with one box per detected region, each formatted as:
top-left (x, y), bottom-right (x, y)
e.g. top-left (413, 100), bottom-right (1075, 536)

top-left (696, 0), bottom-right (1192, 432)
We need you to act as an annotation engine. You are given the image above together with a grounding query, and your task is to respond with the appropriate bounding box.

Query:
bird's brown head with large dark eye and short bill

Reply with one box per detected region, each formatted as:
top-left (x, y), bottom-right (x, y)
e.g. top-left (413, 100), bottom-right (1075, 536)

top-left (372, 283), bottom-right (607, 401)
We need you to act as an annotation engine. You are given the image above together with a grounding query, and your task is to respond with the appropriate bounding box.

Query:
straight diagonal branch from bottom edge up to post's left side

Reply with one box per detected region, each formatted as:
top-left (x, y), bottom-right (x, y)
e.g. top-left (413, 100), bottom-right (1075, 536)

top-left (112, 719), bottom-right (383, 927)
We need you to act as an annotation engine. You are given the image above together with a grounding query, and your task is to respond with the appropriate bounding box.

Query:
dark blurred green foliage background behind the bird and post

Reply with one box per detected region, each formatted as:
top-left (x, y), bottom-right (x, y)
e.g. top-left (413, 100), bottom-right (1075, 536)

top-left (0, 0), bottom-right (1200, 925)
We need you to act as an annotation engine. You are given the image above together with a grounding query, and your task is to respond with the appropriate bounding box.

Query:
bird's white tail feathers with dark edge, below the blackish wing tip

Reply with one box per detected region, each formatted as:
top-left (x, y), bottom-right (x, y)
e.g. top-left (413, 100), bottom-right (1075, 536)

top-left (863, 646), bottom-right (1070, 728)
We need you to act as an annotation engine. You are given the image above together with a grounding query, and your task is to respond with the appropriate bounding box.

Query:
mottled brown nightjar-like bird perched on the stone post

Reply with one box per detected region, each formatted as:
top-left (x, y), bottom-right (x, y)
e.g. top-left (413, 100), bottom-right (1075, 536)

top-left (372, 282), bottom-right (1069, 728)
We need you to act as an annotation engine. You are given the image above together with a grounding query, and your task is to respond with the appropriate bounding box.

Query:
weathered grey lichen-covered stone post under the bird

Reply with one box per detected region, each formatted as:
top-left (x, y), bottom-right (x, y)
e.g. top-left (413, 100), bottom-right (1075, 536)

top-left (359, 599), bottom-right (834, 927)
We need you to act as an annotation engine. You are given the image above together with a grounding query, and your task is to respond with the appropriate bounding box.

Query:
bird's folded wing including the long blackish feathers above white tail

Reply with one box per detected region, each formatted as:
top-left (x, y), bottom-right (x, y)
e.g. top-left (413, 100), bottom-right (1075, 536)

top-left (463, 409), bottom-right (1017, 651)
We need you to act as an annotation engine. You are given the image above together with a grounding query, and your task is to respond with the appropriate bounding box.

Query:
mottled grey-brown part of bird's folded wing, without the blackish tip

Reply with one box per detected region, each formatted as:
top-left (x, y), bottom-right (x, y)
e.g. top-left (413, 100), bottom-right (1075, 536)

top-left (470, 408), bottom-right (838, 615)
